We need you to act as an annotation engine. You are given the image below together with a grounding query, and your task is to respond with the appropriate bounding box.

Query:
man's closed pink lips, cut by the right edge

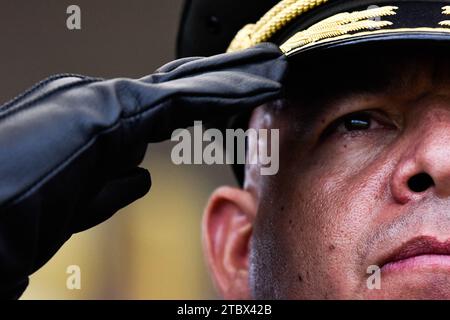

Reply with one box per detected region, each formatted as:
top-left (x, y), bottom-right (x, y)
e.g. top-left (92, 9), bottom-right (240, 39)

top-left (381, 236), bottom-right (450, 272)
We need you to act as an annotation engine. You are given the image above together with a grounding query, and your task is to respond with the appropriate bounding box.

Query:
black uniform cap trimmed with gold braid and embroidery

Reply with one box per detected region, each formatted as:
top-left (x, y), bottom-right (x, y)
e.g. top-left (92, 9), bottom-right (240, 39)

top-left (177, 0), bottom-right (450, 183)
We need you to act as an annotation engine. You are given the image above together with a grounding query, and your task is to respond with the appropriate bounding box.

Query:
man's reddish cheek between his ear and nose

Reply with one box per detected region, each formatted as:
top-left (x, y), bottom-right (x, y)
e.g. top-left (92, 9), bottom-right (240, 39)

top-left (256, 131), bottom-right (395, 298)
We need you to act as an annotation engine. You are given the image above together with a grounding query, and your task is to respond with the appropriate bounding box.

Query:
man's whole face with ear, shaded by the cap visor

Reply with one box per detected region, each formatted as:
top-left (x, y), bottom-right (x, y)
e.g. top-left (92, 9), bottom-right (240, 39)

top-left (203, 45), bottom-right (450, 299)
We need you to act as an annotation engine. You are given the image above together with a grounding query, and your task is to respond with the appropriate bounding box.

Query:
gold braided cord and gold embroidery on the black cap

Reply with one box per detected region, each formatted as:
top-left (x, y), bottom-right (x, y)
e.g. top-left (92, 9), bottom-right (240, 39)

top-left (228, 0), bottom-right (450, 55)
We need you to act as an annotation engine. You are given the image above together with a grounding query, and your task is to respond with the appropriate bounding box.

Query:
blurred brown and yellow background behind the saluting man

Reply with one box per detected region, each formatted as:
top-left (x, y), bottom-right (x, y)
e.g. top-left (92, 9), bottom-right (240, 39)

top-left (0, 0), bottom-right (235, 299)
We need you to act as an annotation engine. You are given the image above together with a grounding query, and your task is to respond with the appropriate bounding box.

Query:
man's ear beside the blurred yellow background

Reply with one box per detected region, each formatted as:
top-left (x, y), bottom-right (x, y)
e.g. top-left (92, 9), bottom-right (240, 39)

top-left (203, 187), bottom-right (257, 299)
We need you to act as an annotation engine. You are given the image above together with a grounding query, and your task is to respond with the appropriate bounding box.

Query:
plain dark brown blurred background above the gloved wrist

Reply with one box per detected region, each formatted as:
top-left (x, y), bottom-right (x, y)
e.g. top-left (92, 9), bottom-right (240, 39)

top-left (0, 0), bottom-right (182, 101)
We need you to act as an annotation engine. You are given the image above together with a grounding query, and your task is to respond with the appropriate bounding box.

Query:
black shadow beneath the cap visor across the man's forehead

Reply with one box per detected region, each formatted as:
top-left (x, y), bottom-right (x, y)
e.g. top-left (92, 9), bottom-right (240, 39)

top-left (283, 46), bottom-right (450, 134)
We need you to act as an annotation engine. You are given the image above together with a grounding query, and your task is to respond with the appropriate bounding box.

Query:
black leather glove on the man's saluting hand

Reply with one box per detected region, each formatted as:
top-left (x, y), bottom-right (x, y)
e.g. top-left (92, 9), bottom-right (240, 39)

top-left (0, 44), bottom-right (286, 298)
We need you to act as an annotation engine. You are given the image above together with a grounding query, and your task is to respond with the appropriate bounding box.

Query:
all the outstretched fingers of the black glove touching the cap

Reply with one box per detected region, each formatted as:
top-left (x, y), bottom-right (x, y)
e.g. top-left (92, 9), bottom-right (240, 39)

top-left (128, 44), bottom-right (287, 142)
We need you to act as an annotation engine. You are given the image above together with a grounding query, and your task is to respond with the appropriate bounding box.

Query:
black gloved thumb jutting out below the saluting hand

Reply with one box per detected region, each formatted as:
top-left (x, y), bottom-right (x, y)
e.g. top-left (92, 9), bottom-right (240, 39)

top-left (71, 168), bottom-right (151, 233)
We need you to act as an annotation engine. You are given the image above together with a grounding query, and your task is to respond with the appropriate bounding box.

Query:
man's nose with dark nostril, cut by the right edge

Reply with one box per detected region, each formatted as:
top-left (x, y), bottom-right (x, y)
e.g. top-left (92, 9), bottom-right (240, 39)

top-left (391, 111), bottom-right (450, 203)
